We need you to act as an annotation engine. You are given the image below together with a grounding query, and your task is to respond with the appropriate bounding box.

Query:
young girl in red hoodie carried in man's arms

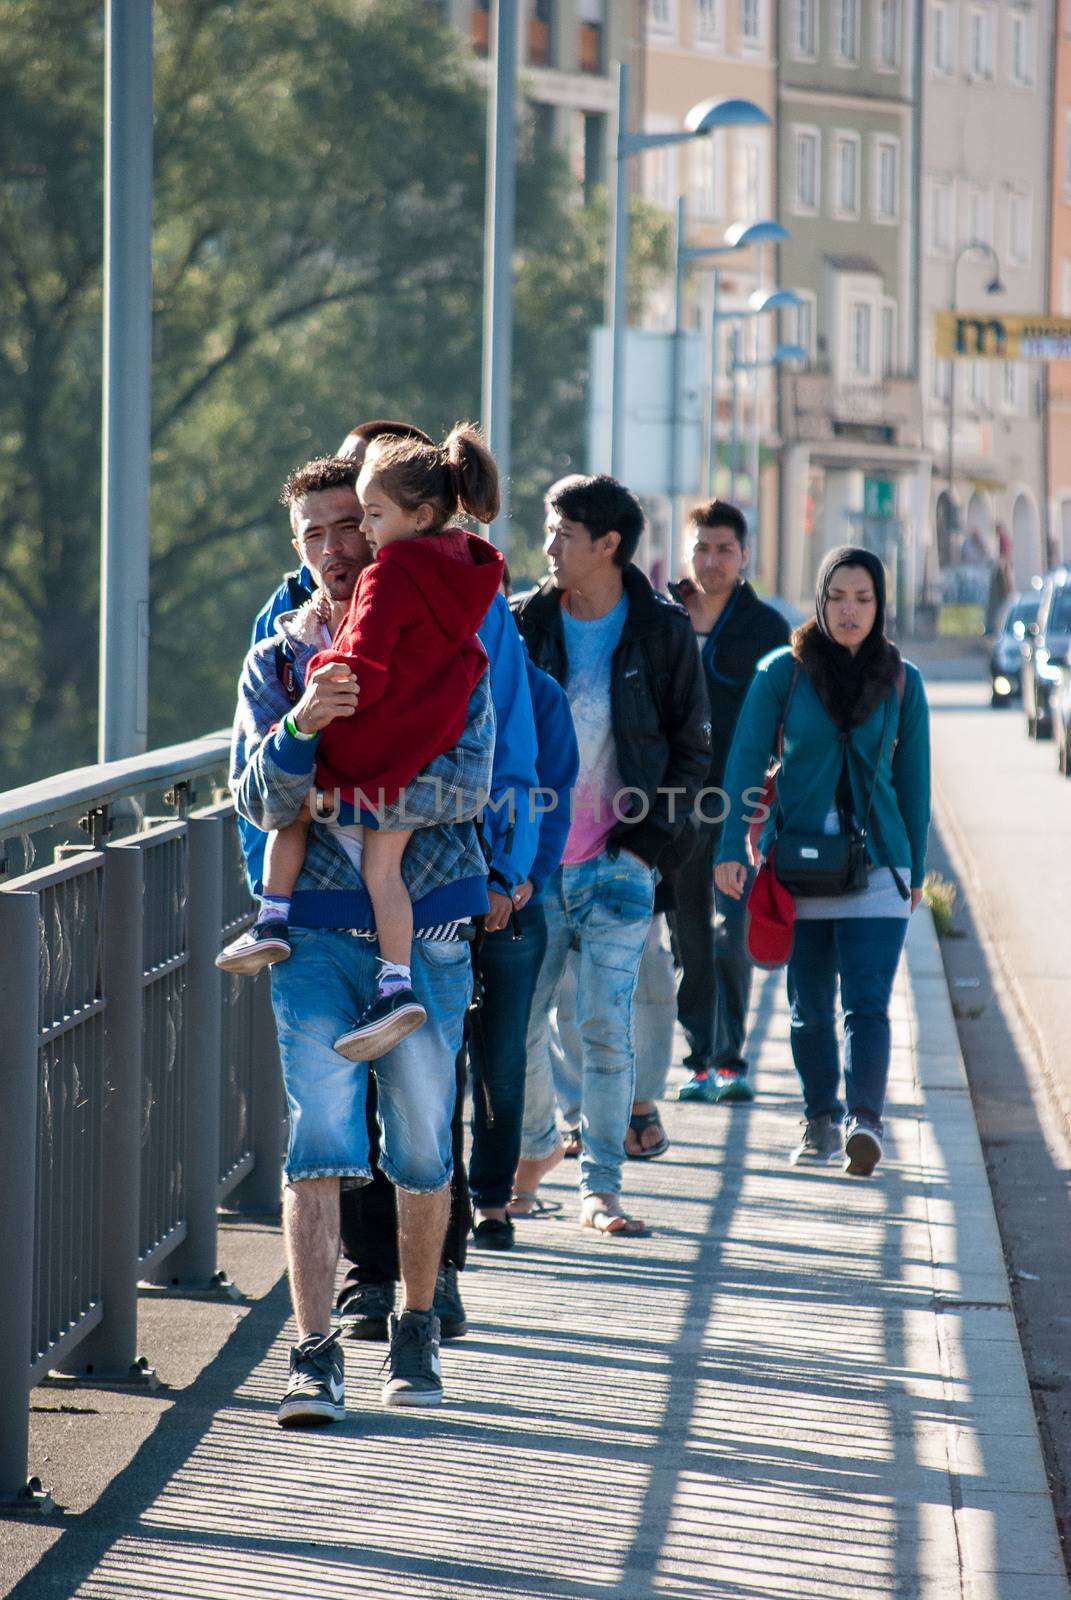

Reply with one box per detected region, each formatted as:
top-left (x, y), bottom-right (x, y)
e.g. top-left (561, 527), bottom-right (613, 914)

top-left (218, 424), bottom-right (503, 1061)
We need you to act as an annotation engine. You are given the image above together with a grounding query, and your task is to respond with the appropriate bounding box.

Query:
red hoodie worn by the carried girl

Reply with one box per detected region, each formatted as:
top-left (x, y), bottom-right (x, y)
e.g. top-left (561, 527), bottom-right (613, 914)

top-left (306, 528), bottom-right (503, 810)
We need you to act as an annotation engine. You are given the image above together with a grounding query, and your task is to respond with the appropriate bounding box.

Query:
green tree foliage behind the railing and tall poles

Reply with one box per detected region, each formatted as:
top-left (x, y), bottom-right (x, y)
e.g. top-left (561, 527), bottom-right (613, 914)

top-left (0, 0), bottom-right (669, 784)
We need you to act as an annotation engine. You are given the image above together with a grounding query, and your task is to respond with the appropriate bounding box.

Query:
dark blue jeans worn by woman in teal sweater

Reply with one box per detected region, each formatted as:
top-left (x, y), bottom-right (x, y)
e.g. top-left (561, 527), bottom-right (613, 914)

top-left (788, 917), bottom-right (908, 1123)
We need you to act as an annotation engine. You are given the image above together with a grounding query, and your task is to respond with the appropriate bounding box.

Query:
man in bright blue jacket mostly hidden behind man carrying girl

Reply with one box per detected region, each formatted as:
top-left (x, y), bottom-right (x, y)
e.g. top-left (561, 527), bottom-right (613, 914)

top-left (243, 419), bottom-right (536, 1339)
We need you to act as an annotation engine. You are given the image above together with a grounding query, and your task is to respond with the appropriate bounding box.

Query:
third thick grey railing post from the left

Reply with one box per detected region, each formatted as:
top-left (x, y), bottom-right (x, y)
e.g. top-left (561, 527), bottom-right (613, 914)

top-left (160, 816), bottom-right (223, 1288)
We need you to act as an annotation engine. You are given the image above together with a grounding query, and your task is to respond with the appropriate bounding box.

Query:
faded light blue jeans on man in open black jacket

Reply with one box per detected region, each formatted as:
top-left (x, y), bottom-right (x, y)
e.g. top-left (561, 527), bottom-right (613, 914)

top-left (520, 850), bottom-right (655, 1195)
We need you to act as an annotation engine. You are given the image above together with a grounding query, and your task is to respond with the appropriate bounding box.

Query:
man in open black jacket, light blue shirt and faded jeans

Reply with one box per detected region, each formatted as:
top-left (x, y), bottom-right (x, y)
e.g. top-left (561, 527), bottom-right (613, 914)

top-left (514, 475), bottom-right (711, 1234)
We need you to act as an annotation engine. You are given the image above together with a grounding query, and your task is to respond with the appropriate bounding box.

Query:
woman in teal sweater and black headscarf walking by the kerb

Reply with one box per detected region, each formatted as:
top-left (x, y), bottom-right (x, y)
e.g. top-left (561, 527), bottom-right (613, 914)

top-left (714, 546), bottom-right (930, 1176)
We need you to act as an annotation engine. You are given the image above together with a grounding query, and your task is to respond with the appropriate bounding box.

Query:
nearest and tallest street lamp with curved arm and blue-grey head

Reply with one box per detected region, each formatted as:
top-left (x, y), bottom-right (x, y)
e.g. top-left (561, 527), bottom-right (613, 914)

top-left (610, 61), bottom-right (770, 478)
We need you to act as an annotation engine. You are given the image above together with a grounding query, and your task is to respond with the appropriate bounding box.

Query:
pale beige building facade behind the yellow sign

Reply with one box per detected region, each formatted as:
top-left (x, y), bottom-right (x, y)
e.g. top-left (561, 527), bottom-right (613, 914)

top-left (919, 0), bottom-right (1053, 598)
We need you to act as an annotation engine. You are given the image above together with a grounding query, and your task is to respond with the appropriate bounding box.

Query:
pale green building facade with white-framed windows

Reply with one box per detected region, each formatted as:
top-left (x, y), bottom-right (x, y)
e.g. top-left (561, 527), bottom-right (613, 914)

top-left (778, 0), bottom-right (930, 622)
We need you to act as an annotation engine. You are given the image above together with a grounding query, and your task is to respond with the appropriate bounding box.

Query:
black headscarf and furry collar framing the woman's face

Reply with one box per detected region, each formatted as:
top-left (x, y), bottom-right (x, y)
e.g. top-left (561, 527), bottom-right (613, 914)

top-left (792, 544), bottom-right (900, 733)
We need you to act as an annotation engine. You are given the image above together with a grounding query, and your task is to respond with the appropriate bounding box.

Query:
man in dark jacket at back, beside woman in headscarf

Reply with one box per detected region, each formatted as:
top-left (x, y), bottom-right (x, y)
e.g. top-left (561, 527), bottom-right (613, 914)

top-left (669, 501), bottom-right (789, 1101)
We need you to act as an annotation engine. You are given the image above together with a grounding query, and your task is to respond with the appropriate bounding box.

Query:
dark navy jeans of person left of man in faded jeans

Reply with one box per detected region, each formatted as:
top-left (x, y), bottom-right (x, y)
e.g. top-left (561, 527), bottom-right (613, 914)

top-left (469, 906), bottom-right (546, 1210)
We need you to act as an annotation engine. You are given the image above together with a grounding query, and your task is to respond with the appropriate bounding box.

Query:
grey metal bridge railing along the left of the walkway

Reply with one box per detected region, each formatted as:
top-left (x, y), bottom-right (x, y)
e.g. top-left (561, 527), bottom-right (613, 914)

top-left (0, 734), bottom-right (285, 1510)
